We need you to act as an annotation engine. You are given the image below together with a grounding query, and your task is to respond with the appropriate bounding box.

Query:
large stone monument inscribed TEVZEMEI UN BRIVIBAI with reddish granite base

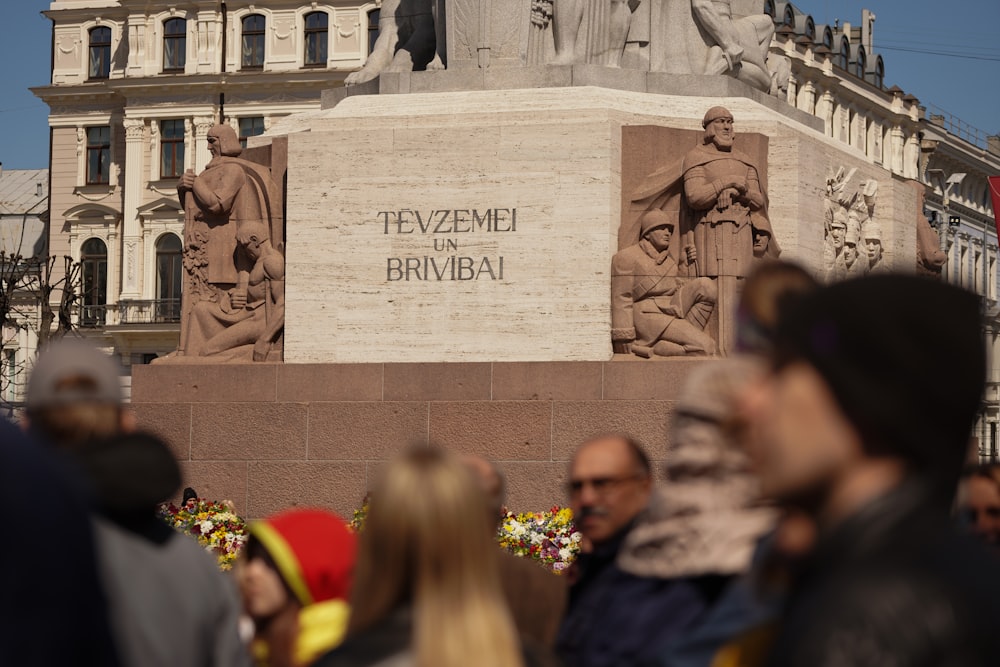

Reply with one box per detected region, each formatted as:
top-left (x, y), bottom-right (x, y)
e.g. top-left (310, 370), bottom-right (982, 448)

top-left (132, 0), bottom-right (919, 517)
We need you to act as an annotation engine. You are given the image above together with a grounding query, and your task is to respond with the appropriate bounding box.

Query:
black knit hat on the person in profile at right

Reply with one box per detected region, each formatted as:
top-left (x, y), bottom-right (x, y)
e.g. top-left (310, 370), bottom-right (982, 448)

top-left (775, 275), bottom-right (986, 484)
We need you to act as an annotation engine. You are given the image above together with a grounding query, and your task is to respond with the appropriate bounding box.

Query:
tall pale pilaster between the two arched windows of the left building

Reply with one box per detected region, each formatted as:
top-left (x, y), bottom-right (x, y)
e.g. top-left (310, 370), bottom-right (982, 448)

top-left (120, 118), bottom-right (146, 301)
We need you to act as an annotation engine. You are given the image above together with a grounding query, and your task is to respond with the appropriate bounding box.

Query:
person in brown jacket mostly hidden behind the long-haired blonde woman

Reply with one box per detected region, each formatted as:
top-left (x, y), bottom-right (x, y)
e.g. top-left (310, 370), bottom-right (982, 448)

top-left (462, 455), bottom-right (566, 649)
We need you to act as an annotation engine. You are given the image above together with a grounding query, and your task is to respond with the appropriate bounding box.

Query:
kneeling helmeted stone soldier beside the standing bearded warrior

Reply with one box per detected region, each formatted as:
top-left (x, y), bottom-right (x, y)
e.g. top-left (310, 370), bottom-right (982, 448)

top-left (611, 209), bottom-right (717, 358)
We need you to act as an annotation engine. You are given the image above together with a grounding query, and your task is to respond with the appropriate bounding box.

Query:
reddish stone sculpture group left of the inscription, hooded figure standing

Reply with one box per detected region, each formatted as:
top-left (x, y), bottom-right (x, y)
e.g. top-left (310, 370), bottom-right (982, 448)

top-left (174, 125), bottom-right (285, 361)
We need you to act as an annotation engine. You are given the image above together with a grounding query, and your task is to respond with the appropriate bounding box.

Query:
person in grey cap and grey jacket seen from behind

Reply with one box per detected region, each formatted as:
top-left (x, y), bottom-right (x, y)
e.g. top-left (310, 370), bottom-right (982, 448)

top-left (25, 339), bottom-right (249, 667)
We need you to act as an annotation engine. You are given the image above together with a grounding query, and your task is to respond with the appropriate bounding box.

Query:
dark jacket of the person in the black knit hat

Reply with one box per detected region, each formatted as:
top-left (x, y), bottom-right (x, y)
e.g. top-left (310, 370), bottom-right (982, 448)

top-left (769, 481), bottom-right (1000, 667)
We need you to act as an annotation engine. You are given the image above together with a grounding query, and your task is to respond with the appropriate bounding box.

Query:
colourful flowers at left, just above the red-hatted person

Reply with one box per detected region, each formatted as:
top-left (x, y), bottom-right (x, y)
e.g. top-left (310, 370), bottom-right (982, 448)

top-left (160, 498), bottom-right (247, 570)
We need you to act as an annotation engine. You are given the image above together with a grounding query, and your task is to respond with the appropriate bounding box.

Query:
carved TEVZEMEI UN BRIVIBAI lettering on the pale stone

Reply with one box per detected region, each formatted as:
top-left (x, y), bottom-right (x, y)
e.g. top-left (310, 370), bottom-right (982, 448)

top-left (375, 208), bottom-right (517, 282)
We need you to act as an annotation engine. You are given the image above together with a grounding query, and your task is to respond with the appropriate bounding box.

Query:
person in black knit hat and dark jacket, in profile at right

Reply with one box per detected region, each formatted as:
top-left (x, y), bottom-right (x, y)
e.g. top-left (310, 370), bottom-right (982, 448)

top-left (739, 275), bottom-right (1000, 667)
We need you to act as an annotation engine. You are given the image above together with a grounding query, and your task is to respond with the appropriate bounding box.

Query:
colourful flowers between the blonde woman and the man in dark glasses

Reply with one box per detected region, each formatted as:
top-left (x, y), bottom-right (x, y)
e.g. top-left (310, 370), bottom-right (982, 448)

top-left (497, 507), bottom-right (583, 573)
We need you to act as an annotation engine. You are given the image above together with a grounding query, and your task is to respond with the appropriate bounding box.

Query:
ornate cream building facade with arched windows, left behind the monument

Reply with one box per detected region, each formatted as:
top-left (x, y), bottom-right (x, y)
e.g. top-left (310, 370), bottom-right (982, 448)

top-left (33, 0), bottom-right (381, 386)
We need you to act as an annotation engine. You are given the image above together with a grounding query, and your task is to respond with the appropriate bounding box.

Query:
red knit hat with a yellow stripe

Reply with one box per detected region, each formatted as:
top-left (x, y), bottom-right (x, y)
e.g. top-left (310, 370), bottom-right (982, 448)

top-left (249, 509), bottom-right (357, 606)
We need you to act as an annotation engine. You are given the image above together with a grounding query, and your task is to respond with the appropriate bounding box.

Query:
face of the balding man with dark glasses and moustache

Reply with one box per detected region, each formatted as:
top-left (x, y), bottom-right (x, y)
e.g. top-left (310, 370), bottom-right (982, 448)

top-left (569, 438), bottom-right (650, 545)
